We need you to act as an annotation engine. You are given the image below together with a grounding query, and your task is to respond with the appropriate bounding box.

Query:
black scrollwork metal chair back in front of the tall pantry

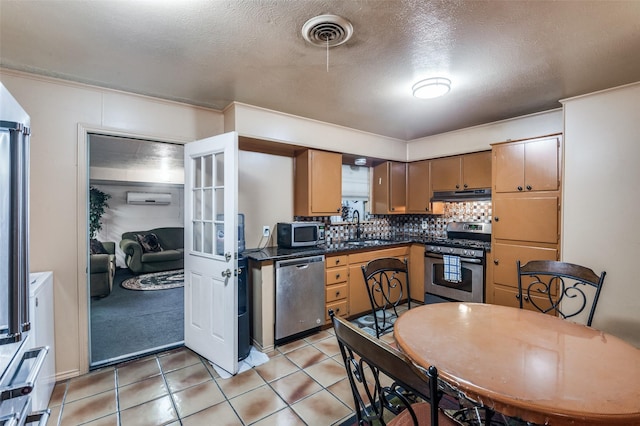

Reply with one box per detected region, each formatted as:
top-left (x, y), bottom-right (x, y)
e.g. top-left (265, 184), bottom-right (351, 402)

top-left (517, 260), bottom-right (606, 326)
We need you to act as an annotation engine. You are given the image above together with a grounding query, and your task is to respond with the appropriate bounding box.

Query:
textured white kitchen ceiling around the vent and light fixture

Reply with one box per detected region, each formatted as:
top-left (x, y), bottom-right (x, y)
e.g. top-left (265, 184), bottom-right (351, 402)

top-left (0, 0), bottom-right (640, 140)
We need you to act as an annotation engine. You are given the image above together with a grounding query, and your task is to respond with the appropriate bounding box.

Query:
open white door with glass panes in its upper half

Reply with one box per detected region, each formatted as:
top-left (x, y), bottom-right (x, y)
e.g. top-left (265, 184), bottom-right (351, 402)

top-left (184, 132), bottom-right (238, 374)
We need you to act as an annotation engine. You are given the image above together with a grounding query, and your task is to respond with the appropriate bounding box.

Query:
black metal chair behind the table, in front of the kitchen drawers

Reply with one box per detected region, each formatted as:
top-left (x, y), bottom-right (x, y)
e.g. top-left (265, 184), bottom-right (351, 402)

top-left (362, 257), bottom-right (411, 338)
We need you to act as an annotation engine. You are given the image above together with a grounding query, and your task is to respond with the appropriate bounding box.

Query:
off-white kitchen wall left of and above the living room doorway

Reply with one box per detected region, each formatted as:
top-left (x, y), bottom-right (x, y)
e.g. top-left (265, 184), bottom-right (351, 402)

top-left (0, 69), bottom-right (223, 379)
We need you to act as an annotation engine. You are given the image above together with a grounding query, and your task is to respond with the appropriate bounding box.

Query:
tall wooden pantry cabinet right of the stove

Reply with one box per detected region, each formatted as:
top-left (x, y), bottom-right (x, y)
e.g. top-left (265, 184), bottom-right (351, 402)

top-left (486, 135), bottom-right (562, 309)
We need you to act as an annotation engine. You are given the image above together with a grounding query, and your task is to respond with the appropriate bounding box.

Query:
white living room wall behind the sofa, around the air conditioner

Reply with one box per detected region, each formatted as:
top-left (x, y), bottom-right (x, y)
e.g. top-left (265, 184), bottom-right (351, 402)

top-left (91, 184), bottom-right (184, 268)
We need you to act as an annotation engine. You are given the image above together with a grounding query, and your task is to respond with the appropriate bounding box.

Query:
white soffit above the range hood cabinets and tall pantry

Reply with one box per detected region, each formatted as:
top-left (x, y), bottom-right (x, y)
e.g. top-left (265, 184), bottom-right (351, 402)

top-left (407, 109), bottom-right (562, 161)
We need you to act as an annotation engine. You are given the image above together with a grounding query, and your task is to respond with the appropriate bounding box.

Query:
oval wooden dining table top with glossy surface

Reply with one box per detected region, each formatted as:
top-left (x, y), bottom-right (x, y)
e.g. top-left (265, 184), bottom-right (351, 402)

top-left (394, 302), bottom-right (640, 425)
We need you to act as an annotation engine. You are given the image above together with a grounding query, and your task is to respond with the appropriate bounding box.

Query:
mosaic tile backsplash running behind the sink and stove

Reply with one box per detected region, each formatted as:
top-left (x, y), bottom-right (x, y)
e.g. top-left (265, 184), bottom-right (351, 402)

top-left (295, 201), bottom-right (492, 243)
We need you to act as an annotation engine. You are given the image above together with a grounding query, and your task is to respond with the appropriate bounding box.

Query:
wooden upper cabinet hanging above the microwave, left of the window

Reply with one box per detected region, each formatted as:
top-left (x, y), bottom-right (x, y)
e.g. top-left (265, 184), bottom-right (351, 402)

top-left (293, 149), bottom-right (342, 216)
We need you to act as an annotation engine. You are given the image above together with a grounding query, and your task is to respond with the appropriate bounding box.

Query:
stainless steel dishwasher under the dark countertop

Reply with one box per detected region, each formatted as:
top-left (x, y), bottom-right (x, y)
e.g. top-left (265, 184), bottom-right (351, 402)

top-left (275, 256), bottom-right (325, 341)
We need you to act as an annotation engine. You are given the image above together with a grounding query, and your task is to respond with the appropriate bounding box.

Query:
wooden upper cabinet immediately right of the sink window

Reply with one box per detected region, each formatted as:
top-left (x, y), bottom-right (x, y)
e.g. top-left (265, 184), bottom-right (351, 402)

top-left (372, 161), bottom-right (407, 214)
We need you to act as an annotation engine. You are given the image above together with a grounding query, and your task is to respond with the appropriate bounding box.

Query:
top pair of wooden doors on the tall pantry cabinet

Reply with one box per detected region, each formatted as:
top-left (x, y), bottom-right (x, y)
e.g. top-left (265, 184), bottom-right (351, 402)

top-left (493, 136), bottom-right (560, 192)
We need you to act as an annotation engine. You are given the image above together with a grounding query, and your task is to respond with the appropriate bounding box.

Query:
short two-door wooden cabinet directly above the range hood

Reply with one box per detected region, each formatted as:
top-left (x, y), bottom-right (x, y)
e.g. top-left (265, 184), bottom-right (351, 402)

top-left (431, 151), bottom-right (491, 191)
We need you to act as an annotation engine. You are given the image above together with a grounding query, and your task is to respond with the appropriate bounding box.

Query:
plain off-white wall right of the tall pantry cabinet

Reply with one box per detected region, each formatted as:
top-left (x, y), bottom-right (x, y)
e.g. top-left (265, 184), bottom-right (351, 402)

top-left (562, 83), bottom-right (640, 347)
